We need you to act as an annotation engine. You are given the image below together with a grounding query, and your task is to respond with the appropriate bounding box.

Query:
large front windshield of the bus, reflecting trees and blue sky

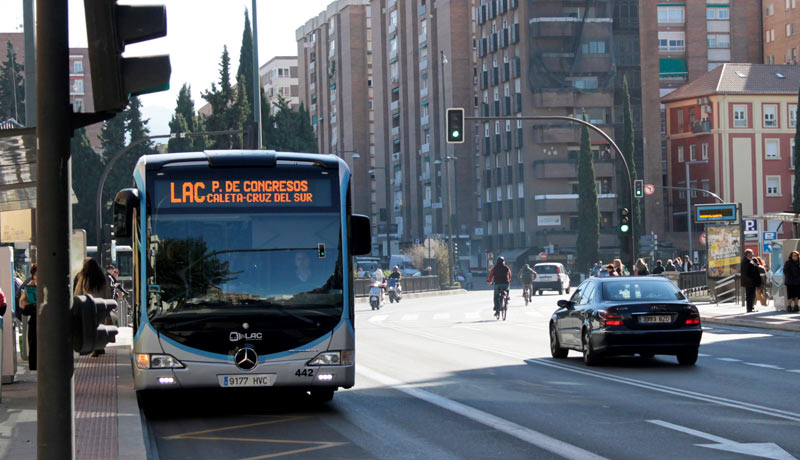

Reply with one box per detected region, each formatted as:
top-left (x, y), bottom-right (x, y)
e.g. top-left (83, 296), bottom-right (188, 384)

top-left (147, 212), bottom-right (343, 323)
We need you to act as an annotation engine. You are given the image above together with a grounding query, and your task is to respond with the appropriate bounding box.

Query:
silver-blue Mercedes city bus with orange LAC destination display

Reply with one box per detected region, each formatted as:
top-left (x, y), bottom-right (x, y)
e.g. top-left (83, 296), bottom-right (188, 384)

top-left (114, 151), bottom-right (371, 406)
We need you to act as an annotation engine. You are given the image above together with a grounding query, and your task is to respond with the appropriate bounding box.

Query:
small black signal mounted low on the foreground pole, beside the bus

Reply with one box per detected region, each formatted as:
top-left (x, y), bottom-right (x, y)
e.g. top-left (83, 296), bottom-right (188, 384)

top-left (72, 295), bottom-right (118, 355)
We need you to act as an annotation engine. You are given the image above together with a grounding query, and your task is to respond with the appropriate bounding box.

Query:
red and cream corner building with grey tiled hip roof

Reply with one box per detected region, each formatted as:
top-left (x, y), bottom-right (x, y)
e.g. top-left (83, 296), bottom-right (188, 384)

top-left (662, 64), bottom-right (800, 252)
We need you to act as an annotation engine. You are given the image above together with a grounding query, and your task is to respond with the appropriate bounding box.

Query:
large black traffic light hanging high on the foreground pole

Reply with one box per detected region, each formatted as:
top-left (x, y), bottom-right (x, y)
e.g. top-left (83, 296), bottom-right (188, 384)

top-left (83, 0), bottom-right (172, 113)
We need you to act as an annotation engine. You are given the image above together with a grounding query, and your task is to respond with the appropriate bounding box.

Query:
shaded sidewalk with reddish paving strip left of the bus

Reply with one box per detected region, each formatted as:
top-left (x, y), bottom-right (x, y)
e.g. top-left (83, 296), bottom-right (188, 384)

top-left (0, 328), bottom-right (147, 460)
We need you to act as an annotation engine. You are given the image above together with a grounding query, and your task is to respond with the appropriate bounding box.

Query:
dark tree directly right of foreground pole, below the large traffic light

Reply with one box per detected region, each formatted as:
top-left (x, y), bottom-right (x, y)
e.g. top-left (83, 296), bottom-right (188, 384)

top-left (70, 128), bottom-right (105, 245)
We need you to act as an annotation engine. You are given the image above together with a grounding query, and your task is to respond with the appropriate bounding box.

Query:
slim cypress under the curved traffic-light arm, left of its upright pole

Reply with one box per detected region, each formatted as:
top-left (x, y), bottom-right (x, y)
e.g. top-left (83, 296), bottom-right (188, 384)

top-left (575, 126), bottom-right (600, 273)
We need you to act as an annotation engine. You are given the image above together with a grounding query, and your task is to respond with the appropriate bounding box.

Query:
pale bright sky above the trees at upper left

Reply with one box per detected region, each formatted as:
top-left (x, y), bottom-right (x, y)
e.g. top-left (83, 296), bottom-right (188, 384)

top-left (0, 0), bottom-right (332, 140)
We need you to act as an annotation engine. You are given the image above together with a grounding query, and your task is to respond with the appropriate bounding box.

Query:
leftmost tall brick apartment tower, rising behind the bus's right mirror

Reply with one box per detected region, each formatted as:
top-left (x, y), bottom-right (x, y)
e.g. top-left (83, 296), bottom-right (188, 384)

top-left (290, 0), bottom-right (376, 230)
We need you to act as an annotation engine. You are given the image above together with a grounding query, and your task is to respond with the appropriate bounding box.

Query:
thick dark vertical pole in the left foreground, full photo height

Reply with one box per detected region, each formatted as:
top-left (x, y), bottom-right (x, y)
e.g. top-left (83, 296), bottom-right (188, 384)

top-left (36, 0), bottom-right (75, 460)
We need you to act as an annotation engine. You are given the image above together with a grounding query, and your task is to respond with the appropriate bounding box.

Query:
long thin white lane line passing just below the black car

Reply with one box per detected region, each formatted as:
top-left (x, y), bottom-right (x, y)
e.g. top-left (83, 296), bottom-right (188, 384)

top-left (381, 323), bottom-right (800, 422)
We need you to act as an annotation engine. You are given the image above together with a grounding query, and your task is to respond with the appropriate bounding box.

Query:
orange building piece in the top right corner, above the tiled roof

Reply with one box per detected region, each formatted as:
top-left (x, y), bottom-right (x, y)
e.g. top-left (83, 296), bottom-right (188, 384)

top-left (761, 0), bottom-right (800, 65)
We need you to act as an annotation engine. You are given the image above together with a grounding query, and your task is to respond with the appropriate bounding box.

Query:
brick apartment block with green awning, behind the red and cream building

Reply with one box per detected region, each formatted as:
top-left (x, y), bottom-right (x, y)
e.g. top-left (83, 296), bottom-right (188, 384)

top-left (639, 0), bottom-right (764, 240)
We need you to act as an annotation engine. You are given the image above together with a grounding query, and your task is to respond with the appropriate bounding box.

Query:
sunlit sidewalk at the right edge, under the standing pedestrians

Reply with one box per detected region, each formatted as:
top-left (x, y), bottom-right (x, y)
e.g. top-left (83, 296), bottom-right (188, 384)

top-left (695, 302), bottom-right (800, 332)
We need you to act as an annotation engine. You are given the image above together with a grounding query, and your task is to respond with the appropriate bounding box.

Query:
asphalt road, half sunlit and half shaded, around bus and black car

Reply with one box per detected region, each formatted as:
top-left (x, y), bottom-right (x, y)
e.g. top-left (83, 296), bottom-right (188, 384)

top-left (142, 290), bottom-right (800, 460)
